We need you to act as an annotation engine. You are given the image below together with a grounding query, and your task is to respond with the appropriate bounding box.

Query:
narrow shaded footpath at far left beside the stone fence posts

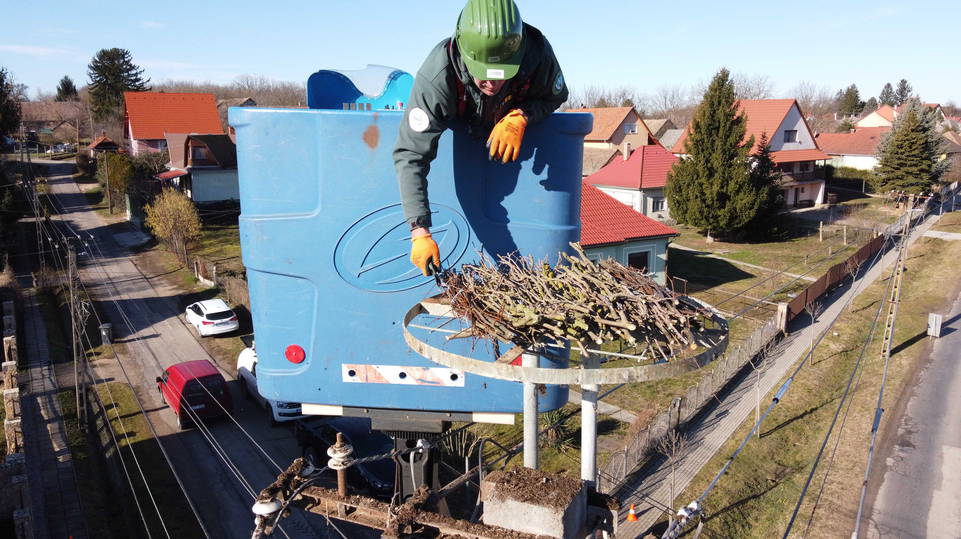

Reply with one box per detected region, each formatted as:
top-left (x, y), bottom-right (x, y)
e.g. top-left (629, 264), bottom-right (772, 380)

top-left (21, 289), bottom-right (87, 539)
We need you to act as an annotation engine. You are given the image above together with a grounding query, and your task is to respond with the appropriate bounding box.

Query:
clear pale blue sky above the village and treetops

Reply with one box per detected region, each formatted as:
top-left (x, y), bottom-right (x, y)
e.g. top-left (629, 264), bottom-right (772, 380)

top-left (0, 0), bottom-right (961, 103)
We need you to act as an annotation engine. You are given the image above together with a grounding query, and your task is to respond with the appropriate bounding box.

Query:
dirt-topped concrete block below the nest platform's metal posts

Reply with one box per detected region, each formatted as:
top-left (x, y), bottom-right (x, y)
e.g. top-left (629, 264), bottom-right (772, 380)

top-left (481, 468), bottom-right (587, 539)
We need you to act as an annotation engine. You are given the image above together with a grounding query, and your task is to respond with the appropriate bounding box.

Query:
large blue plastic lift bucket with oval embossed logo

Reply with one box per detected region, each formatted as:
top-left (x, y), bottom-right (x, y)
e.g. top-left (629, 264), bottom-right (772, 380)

top-left (230, 107), bottom-right (592, 413)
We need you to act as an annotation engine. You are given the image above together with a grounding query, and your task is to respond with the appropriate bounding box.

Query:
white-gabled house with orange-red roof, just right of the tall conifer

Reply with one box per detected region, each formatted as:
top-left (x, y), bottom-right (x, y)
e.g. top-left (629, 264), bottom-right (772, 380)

top-left (672, 99), bottom-right (831, 207)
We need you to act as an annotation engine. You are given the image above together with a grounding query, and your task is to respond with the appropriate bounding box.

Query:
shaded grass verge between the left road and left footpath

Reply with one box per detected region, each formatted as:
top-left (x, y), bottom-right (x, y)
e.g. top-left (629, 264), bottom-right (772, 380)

top-left (94, 382), bottom-right (203, 537)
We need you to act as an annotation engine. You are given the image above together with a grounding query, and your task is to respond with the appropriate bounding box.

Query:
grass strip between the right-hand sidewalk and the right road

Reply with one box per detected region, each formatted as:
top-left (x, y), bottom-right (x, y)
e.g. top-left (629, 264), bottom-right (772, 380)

top-left (677, 230), bottom-right (961, 537)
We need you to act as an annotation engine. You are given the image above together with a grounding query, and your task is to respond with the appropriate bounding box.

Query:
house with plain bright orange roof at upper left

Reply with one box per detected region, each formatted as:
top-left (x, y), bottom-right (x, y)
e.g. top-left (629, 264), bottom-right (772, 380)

top-left (123, 92), bottom-right (224, 155)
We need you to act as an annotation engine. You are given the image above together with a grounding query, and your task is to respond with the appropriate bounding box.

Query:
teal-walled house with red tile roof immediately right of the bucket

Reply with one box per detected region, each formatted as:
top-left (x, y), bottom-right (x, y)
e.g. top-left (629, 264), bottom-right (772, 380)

top-left (581, 181), bottom-right (678, 285)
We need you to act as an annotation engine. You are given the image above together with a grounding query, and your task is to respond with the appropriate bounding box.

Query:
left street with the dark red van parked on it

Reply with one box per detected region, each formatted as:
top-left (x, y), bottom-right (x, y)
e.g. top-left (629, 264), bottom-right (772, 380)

top-left (35, 164), bottom-right (366, 538)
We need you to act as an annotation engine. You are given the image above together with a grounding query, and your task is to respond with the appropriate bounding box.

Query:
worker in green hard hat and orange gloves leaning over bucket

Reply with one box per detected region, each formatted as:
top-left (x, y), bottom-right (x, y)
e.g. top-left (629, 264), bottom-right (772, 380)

top-left (394, 0), bottom-right (567, 275)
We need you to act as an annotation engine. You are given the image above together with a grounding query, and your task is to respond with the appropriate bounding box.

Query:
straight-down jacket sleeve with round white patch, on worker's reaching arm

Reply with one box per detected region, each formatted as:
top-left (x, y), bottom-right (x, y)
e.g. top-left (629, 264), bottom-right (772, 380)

top-left (394, 60), bottom-right (454, 227)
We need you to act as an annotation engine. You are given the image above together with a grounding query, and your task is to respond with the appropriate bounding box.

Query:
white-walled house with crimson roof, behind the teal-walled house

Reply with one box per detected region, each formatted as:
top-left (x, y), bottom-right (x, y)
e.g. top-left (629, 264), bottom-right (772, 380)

top-left (585, 145), bottom-right (679, 221)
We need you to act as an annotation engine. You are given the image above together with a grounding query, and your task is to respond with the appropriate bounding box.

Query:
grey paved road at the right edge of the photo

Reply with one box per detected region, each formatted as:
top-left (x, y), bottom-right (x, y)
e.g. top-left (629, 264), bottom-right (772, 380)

top-left (866, 288), bottom-right (961, 538)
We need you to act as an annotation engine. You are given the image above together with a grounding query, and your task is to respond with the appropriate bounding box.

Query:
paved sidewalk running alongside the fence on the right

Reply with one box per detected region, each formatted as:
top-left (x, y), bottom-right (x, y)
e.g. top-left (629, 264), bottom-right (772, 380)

top-left (616, 206), bottom-right (937, 537)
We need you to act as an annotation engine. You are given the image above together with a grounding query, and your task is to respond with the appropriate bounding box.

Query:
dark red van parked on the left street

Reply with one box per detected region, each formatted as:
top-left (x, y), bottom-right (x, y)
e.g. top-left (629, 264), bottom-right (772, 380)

top-left (157, 359), bottom-right (233, 429)
